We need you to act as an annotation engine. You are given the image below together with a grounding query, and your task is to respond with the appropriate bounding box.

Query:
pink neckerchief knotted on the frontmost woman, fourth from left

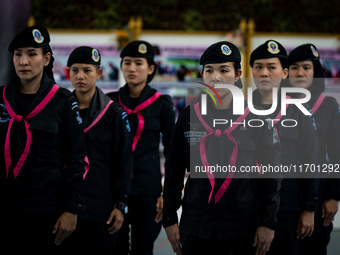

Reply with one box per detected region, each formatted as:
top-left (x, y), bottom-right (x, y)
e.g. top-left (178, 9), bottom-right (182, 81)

top-left (194, 103), bottom-right (250, 204)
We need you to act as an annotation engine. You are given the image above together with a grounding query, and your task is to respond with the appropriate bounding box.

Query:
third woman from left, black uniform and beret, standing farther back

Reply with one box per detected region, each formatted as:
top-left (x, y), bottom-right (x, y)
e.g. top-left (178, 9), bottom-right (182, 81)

top-left (108, 41), bottom-right (175, 255)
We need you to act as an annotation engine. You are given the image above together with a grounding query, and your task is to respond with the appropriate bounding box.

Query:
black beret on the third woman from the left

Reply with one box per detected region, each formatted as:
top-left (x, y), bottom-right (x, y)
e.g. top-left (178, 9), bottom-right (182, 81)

top-left (120, 41), bottom-right (155, 59)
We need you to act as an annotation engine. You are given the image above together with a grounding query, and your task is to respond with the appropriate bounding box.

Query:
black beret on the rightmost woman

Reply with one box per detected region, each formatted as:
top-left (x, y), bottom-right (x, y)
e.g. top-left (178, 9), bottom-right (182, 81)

top-left (288, 43), bottom-right (319, 65)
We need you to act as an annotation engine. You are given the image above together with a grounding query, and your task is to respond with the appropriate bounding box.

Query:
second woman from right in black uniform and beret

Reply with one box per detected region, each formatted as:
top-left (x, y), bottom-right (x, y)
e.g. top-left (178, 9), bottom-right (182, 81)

top-left (250, 40), bottom-right (320, 255)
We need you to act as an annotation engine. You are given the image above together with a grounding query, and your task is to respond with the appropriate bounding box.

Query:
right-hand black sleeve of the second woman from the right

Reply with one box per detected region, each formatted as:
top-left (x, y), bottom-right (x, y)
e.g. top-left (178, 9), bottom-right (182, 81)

top-left (297, 108), bottom-right (321, 211)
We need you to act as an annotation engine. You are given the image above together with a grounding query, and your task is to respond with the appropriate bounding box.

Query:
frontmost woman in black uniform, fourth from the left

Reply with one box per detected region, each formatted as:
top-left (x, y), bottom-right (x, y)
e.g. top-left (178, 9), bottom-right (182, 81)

top-left (163, 41), bottom-right (281, 255)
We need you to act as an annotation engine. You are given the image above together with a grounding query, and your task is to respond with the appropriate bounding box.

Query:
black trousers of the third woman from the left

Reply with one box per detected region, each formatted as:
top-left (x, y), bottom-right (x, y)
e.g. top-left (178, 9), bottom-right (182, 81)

top-left (114, 195), bottom-right (161, 255)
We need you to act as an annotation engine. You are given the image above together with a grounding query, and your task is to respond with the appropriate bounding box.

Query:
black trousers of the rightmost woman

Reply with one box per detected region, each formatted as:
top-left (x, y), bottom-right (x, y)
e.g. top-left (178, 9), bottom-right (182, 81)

top-left (299, 212), bottom-right (333, 255)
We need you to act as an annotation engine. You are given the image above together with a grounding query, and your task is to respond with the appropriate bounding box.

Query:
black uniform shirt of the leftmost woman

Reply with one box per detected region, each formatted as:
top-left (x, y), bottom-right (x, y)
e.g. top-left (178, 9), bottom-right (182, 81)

top-left (0, 74), bottom-right (85, 223)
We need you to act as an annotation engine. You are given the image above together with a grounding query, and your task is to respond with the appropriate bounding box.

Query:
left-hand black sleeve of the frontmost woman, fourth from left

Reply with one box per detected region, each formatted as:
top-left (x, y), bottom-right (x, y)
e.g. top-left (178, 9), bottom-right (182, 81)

top-left (163, 111), bottom-right (186, 228)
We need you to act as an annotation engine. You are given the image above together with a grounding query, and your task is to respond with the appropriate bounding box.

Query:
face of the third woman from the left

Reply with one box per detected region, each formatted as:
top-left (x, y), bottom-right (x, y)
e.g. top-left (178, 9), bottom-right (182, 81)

top-left (122, 56), bottom-right (155, 86)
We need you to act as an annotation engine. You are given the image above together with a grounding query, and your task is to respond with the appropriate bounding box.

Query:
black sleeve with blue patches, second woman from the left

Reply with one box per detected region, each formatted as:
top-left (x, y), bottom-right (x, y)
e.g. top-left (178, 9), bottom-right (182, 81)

top-left (112, 106), bottom-right (133, 204)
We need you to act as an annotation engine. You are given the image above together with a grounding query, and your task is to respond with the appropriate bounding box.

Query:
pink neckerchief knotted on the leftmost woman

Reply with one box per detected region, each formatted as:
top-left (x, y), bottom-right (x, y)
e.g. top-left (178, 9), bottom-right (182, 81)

top-left (2, 84), bottom-right (59, 178)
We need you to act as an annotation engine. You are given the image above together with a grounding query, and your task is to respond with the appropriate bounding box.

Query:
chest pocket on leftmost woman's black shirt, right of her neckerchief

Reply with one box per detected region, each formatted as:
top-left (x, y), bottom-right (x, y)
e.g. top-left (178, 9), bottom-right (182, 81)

top-left (29, 119), bottom-right (60, 155)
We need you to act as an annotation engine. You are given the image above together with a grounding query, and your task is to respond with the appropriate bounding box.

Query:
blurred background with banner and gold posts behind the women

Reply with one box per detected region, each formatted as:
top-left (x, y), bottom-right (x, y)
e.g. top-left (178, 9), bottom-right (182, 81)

top-left (0, 0), bottom-right (340, 254)
